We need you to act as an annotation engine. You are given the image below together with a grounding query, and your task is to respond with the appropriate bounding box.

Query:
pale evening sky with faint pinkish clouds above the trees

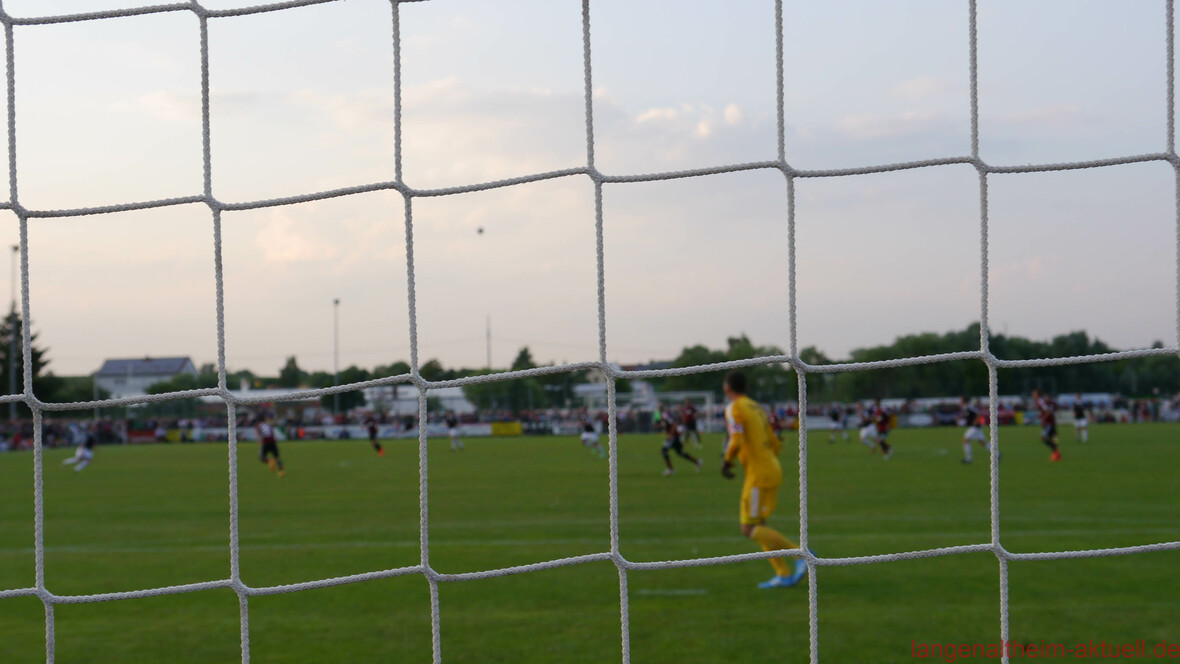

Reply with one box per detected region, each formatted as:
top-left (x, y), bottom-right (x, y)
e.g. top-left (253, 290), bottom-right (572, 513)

top-left (0, 0), bottom-right (1178, 375)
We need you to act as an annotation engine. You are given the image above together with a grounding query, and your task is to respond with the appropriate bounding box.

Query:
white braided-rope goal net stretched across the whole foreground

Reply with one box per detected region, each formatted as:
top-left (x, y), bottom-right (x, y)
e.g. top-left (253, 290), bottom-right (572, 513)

top-left (0, 0), bottom-right (1180, 663)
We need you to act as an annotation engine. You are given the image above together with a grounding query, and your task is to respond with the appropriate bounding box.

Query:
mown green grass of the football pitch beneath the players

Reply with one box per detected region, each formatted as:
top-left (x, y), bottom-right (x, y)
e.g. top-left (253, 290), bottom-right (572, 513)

top-left (0, 425), bottom-right (1180, 663)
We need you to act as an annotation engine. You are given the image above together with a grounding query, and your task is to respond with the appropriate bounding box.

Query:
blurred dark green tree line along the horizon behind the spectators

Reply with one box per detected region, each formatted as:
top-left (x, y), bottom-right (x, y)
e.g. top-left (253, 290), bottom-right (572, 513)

top-left (0, 314), bottom-right (1180, 415)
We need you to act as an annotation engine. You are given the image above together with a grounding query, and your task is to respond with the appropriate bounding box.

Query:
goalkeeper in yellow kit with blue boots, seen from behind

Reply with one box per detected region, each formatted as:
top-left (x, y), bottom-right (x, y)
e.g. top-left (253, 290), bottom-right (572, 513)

top-left (721, 372), bottom-right (807, 589)
